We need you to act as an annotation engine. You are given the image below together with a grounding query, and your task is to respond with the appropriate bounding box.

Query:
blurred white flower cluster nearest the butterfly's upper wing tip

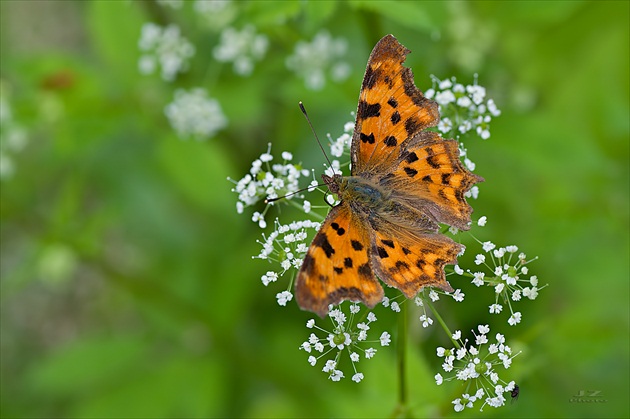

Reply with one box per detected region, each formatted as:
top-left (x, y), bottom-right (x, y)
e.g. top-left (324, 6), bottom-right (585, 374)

top-left (286, 30), bottom-right (350, 90)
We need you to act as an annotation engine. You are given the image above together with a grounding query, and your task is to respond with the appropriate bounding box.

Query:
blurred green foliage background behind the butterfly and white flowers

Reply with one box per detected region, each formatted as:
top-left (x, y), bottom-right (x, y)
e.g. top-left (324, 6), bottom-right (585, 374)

top-left (0, 0), bottom-right (630, 417)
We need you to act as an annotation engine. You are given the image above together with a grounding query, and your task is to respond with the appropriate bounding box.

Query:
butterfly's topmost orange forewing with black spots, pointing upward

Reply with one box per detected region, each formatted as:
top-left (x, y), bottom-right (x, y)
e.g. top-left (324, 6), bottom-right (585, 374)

top-left (351, 35), bottom-right (439, 177)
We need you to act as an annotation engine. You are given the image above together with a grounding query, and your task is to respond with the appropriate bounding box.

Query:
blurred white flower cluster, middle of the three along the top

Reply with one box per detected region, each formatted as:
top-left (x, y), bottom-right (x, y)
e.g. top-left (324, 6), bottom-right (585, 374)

top-left (213, 25), bottom-right (269, 76)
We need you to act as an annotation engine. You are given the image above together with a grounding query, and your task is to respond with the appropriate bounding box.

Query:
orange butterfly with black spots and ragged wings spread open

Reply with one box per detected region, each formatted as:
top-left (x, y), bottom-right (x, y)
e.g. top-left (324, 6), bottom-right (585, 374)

top-left (295, 35), bottom-right (483, 317)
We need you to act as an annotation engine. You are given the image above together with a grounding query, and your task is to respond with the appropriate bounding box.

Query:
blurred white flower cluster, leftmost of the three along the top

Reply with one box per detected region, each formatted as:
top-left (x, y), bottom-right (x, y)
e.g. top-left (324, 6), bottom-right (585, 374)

top-left (138, 23), bottom-right (195, 81)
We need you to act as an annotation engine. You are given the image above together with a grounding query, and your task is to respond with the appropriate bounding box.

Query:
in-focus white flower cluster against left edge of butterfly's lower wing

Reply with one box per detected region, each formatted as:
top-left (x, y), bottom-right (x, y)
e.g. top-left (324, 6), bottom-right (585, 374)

top-left (254, 220), bottom-right (320, 306)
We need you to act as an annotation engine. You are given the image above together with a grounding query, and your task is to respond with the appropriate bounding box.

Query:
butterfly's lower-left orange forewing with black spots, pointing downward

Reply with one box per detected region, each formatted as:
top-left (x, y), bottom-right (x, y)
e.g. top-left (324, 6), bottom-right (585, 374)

top-left (295, 202), bottom-right (383, 317)
